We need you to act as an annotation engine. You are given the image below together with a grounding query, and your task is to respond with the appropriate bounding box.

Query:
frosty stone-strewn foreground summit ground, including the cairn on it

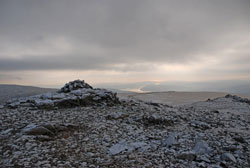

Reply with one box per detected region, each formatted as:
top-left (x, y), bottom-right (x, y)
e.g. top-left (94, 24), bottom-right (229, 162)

top-left (0, 81), bottom-right (250, 168)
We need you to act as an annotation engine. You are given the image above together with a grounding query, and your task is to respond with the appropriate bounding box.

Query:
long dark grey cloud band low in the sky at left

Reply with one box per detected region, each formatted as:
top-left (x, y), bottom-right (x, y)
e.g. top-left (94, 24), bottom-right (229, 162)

top-left (0, 55), bottom-right (156, 72)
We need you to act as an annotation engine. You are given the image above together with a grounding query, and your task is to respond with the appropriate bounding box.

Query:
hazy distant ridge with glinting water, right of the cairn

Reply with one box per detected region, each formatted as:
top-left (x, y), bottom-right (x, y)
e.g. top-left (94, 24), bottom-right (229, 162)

top-left (95, 80), bottom-right (250, 96)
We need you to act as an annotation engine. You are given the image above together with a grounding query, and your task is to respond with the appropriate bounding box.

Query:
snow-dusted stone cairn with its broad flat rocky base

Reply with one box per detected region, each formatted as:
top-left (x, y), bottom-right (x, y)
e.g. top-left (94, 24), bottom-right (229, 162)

top-left (5, 80), bottom-right (119, 108)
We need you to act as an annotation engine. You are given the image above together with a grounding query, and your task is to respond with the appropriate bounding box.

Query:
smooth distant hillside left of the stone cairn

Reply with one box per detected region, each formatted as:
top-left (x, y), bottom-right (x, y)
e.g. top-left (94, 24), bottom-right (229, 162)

top-left (0, 84), bottom-right (57, 104)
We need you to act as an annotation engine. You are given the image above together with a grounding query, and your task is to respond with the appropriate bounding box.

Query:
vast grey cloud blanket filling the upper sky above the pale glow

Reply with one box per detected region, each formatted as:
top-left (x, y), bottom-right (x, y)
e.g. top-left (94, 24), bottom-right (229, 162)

top-left (0, 0), bottom-right (250, 71)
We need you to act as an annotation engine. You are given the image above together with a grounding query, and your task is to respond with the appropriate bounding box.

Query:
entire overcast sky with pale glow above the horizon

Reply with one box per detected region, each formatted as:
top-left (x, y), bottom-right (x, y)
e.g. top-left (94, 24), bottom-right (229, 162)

top-left (0, 0), bottom-right (250, 90)
